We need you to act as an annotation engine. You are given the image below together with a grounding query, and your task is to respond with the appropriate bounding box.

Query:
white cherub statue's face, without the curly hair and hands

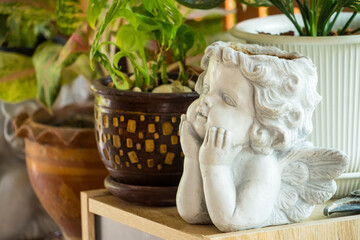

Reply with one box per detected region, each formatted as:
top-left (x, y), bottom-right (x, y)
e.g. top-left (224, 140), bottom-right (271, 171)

top-left (193, 58), bottom-right (255, 144)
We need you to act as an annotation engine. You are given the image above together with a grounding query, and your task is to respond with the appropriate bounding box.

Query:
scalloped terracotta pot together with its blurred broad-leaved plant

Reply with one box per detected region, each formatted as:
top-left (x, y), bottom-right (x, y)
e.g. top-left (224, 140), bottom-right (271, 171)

top-left (0, 0), bottom-right (107, 239)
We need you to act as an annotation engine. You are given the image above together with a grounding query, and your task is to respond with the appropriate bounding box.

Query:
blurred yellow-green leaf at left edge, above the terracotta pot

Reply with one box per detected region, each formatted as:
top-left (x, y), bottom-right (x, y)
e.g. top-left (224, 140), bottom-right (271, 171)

top-left (0, 51), bottom-right (36, 103)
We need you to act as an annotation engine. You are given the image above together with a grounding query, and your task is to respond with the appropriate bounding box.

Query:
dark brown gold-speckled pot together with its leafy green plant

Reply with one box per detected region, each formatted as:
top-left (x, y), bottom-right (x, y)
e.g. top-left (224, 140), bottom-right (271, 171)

top-left (89, 0), bottom-right (205, 206)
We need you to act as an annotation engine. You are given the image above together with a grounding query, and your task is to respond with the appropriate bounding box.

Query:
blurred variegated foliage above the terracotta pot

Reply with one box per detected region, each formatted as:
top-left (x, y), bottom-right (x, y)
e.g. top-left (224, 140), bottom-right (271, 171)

top-left (0, 0), bottom-right (100, 112)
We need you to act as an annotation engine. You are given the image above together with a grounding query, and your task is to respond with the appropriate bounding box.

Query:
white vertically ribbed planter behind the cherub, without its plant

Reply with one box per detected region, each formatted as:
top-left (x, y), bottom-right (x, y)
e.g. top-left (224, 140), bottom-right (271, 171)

top-left (231, 13), bottom-right (360, 197)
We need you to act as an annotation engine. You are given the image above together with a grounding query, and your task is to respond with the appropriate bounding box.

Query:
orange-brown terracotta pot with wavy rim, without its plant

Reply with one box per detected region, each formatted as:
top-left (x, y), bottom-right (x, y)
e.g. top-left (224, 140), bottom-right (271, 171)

top-left (14, 105), bottom-right (108, 239)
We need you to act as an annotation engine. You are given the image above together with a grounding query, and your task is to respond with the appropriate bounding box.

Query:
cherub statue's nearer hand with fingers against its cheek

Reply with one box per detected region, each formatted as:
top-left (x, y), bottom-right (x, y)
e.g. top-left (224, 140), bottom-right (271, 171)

top-left (199, 127), bottom-right (235, 165)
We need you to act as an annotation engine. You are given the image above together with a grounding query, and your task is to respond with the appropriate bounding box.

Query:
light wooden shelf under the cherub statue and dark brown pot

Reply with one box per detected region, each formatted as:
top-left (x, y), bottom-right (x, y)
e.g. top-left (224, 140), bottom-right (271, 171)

top-left (81, 189), bottom-right (360, 240)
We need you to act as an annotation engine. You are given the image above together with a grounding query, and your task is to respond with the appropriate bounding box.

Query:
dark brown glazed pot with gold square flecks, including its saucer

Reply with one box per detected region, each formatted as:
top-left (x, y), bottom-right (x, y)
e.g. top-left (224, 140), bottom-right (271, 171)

top-left (91, 78), bottom-right (198, 206)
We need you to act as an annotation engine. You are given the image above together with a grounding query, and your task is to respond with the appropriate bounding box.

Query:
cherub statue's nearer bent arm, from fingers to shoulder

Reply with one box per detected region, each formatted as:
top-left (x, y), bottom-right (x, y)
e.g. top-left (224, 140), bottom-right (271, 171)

top-left (199, 128), bottom-right (280, 232)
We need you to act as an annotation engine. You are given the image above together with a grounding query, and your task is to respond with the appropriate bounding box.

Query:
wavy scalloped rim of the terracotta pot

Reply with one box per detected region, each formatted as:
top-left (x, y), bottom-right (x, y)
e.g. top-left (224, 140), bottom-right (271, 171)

top-left (13, 102), bottom-right (96, 147)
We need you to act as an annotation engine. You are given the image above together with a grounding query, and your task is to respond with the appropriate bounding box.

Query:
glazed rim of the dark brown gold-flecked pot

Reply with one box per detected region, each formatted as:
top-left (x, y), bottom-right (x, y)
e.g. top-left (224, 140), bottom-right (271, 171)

top-left (90, 76), bottom-right (199, 100)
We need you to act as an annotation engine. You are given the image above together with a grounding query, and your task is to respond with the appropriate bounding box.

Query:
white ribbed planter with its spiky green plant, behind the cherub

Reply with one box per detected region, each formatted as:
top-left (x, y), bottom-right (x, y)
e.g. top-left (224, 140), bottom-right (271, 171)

top-left (184, 0), bottom-right (360, 197)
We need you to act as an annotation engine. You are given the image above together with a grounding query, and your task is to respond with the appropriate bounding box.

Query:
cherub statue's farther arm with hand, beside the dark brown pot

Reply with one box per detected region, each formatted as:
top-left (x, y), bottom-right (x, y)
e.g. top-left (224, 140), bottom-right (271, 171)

top-left (176, 119), bottom-right (211, 224)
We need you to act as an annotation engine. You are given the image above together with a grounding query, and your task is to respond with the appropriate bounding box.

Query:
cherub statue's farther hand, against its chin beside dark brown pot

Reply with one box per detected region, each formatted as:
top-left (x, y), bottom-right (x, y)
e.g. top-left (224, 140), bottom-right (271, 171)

top-left (179, 114), bottom-right (201, 159)
